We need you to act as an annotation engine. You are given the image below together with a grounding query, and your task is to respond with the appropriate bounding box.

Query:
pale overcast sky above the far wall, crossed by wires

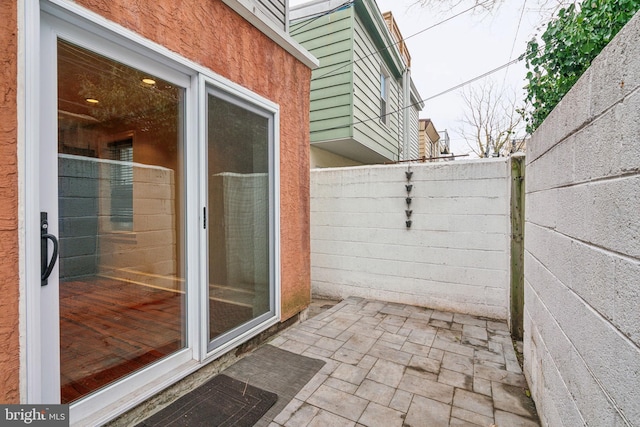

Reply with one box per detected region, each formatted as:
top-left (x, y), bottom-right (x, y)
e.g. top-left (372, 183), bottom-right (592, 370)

top-left (289, 0), bottom-right (541, 157)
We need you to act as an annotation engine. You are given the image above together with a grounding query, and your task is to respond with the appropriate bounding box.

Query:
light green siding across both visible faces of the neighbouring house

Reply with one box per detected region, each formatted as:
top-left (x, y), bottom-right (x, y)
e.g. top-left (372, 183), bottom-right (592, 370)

top-left (290, 0), bottom-right (417, 164)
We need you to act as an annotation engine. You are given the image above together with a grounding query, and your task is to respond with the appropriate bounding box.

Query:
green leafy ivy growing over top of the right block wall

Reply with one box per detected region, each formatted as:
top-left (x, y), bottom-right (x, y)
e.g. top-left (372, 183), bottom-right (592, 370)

top-left (524, 0), bottom-right (640, 133)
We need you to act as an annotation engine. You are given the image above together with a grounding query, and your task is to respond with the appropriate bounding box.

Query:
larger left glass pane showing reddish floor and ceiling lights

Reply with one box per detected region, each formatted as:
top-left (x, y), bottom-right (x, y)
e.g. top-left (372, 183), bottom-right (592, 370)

top-left (58, 41), bottom-right (186, 403)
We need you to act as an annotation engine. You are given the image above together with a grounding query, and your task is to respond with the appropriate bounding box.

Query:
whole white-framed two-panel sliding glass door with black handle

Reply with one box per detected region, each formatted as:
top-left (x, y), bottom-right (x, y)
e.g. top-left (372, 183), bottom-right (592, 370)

top-left (31, 8), bottom-right (279, 422)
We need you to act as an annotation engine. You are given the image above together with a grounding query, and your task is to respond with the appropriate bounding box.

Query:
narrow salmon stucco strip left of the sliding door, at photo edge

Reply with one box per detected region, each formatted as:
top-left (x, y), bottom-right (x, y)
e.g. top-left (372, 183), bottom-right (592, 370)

top-left (0, 0), bottom-right (20, 403)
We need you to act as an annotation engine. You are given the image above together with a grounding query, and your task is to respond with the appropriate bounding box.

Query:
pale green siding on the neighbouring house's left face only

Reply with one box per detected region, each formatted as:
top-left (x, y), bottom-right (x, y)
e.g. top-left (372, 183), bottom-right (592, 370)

top-left (291, 7), bottom-right (354, 143)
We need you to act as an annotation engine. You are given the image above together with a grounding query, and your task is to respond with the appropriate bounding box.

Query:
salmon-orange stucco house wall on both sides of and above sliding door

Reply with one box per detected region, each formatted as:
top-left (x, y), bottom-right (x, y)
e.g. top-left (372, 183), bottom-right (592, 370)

top-left (0, 0), bottom-right (311, 403)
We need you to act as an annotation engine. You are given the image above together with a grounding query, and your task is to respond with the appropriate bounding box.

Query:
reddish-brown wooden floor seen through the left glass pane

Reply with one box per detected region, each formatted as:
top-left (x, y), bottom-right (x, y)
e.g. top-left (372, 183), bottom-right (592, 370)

top-left (60, 277), bottom-right (185, 403)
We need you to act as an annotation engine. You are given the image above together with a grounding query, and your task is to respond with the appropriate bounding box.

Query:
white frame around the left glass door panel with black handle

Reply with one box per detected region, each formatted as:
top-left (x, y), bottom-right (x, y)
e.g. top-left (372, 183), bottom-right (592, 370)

top-left (21, 2), bottom-right (201, 423)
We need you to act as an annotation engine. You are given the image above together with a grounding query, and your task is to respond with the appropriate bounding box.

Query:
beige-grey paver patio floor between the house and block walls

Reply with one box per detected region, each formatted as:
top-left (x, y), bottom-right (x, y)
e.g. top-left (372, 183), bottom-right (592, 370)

top-left (270, 298), bottom-right (540, 427)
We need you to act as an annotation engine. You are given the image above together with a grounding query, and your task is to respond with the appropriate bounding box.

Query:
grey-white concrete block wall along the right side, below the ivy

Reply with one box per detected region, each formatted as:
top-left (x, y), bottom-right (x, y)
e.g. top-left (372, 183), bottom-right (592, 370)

top-left (524, 10), bottom-right (640, 427)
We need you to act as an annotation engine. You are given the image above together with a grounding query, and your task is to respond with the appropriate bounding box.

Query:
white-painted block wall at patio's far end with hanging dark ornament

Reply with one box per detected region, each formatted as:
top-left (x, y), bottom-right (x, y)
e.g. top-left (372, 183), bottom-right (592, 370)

top-left (311, 159), bottom-right (511, 319)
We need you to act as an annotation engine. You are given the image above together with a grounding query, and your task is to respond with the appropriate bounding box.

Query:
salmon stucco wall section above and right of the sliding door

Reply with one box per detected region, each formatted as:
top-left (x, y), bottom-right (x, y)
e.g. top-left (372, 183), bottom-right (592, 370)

top-left (77, 0), bottom-right (311, 320)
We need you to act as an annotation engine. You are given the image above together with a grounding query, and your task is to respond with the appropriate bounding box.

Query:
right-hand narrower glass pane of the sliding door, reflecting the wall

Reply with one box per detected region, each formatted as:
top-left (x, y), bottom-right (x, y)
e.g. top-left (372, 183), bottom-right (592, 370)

top-left (208, 95), bottom-right (270, 339)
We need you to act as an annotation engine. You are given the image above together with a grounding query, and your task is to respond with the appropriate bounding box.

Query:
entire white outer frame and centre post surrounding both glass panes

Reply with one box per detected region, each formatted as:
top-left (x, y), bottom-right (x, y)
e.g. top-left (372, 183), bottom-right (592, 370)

top-left (18, 0), bottom-right (281, 425)
